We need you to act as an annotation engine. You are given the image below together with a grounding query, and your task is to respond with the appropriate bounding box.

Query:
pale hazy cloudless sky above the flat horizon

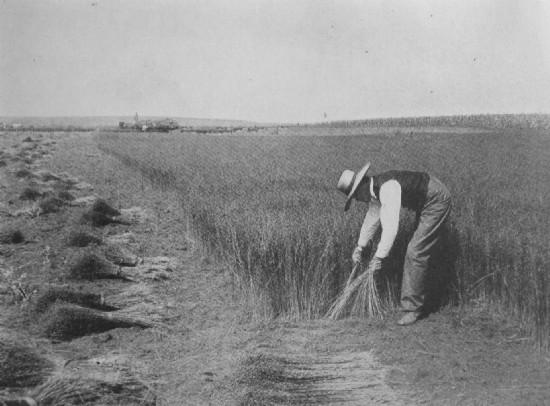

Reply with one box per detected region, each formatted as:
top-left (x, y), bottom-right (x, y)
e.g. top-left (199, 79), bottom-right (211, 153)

top-left (0, 0), bottom-right (550, 122)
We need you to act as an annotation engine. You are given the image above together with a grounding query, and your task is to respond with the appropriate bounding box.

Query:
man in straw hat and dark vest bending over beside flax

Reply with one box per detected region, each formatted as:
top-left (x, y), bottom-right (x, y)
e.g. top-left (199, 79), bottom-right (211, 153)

top-left (338, 163), bottom-right (451, 326)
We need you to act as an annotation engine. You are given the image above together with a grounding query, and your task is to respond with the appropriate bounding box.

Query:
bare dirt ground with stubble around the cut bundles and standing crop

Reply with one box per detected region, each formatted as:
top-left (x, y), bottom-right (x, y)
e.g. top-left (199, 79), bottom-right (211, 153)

top-left (0, 132), bottom-right (550, 405)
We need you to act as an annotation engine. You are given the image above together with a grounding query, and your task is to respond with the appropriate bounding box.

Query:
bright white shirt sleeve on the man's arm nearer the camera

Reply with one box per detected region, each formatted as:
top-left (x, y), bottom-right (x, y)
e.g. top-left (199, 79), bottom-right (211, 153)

top-left (375, 180), bottom-right (401, 258)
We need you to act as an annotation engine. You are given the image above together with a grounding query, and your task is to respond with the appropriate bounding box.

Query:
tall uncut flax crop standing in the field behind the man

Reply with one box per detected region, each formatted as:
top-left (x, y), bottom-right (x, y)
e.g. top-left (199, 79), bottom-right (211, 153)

top-left (98, 120), bottom-right (550, 343)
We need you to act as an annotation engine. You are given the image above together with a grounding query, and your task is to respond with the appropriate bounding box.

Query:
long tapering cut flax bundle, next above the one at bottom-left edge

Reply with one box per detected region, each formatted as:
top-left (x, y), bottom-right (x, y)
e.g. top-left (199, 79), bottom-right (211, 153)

top-left (39, 303), bottom-right (154, 341)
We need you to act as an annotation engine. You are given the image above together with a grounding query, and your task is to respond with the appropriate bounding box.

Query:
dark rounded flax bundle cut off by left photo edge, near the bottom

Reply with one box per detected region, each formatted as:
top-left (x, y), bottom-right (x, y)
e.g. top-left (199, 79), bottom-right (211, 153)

top-left (0, 338), bottom-right (54, 388)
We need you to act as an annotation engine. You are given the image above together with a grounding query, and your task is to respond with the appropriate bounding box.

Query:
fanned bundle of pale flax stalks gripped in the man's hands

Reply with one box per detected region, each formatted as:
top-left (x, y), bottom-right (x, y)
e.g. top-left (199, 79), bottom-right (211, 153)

top-left (327, 263), bottom-right (383, 320)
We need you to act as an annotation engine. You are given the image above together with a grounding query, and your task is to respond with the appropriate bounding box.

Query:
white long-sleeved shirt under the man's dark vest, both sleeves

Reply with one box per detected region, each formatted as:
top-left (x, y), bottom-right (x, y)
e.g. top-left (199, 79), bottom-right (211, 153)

top-left (357, 178), bottom-right (401, 258)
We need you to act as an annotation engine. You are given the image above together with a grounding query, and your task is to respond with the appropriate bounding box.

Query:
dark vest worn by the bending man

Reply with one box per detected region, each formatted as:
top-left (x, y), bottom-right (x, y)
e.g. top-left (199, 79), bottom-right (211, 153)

top-left (372, 171), bottom-right (430, 212)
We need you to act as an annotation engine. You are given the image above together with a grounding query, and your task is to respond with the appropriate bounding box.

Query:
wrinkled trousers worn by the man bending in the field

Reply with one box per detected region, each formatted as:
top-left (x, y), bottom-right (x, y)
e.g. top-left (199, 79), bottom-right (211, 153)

top-left (401, 175), bottom-right (451, 312)
